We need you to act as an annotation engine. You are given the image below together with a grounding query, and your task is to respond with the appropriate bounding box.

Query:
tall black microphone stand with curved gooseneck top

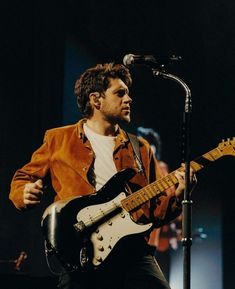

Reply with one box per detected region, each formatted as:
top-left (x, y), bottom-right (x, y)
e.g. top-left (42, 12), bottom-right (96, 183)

top-left (152, 65), bottom-right (193, 289)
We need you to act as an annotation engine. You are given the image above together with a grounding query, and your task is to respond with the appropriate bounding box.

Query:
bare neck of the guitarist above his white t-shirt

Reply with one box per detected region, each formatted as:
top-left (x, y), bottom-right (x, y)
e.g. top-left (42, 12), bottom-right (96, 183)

top-left (86, 118), bottom-right (118, 136)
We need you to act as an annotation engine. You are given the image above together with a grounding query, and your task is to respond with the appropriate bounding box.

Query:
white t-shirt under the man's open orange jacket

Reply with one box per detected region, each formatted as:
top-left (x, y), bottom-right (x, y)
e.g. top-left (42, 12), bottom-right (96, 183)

top-left (84, 124), bottom-right (117, 191)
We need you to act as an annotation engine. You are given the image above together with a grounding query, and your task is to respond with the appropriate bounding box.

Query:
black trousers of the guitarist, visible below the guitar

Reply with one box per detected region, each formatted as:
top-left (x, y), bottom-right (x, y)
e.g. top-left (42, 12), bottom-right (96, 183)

top-left (58, 254), bottom-right (170, 289)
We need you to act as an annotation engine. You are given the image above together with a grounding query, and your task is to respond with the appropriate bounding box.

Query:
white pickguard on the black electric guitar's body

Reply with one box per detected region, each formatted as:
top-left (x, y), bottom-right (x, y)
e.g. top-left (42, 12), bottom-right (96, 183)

top-left (77, 193), bottom-right (152, 266)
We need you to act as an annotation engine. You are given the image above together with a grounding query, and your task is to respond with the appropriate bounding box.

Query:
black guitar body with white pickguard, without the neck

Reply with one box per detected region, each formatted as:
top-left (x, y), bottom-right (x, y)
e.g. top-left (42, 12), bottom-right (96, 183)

top-left (42, 169), bottom-right (152, 271)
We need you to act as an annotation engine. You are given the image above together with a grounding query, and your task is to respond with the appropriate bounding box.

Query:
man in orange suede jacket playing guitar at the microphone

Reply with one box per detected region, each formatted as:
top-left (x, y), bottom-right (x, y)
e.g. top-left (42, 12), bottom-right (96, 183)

top-left (10, 63), bottom-right (193, 289)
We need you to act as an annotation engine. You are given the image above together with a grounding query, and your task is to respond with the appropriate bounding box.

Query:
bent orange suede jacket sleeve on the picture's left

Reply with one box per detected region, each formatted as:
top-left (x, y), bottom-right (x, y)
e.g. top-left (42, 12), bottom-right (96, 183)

top-left (9, 133), bottom-right (50, 209)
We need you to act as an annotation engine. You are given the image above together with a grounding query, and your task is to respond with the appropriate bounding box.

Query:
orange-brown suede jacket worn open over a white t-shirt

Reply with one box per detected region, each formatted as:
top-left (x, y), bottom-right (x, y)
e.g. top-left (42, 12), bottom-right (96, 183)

top-left (9, 119), bottom-right (181, 226)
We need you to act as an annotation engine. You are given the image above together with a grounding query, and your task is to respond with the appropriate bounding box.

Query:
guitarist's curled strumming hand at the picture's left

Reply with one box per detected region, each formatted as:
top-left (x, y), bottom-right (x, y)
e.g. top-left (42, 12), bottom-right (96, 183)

top-left (23, 179), bottom-right (43, 207)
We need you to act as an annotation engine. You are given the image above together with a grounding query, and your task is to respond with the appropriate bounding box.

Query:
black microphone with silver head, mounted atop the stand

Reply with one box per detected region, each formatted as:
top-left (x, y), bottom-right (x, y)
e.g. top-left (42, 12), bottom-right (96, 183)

top-left (123, 54), bottom-right (181, 68)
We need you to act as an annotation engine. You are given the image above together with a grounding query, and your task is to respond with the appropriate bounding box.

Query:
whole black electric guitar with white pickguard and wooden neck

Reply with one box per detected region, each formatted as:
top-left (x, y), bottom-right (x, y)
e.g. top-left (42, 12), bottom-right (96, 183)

top-left (41, 137), bottom-right (235, 271)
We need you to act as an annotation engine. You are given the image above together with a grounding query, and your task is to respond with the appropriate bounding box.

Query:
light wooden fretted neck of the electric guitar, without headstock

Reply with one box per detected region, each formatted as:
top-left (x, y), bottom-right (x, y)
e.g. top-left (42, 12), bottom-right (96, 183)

top-left (122, 147), bottom-right (224, 212)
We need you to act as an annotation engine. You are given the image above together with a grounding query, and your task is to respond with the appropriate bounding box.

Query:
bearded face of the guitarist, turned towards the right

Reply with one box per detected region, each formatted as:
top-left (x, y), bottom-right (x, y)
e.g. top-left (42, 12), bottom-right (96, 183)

top-left (100, 78), bottom-right (132, 124)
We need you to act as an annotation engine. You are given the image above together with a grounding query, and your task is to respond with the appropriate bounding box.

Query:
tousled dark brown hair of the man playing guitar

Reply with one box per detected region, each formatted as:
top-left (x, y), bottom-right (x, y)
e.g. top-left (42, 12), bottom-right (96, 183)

top-left (74, 63), bottom-right (132, 117)
